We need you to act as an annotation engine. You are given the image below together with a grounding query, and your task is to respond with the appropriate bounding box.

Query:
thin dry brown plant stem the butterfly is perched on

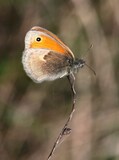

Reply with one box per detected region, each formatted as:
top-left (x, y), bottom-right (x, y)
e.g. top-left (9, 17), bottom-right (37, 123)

top-left (47, 73), bottom-right (76, 160)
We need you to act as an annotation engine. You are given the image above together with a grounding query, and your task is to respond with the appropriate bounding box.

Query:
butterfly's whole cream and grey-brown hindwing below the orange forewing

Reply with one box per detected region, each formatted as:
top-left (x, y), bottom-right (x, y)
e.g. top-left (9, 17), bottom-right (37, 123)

top-left (24, 50), bottom-right (73, 83)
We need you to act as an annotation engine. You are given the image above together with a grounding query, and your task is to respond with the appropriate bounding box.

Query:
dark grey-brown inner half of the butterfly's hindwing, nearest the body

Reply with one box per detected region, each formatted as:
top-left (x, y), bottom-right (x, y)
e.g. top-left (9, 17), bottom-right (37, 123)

top-left (38, 51), bottom-right (71, 80)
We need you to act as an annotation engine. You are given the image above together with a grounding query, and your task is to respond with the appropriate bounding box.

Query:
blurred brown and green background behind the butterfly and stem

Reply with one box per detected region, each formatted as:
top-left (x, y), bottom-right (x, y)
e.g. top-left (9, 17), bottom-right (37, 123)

top-left (0, 0), bottom-right (119, 160)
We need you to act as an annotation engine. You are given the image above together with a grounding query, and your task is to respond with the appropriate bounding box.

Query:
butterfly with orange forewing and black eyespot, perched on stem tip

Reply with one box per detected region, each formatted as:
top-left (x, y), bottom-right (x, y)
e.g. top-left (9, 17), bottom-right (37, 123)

top-left (22, 26), bottom-right (85, 83)
